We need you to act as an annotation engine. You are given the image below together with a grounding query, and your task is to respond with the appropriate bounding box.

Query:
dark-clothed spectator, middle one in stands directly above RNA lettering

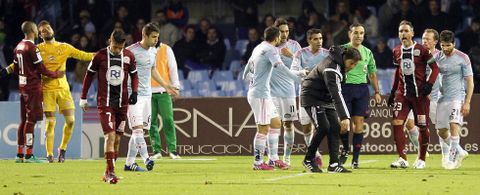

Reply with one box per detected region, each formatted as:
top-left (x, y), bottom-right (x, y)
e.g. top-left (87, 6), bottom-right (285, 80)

top-left (197, 27), bottom-right (226, 70)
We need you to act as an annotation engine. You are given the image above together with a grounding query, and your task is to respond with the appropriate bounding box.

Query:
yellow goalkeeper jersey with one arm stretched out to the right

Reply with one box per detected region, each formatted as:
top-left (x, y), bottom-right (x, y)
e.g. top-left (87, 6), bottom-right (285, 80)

top-left (37, 41), bottom-right (95, 90)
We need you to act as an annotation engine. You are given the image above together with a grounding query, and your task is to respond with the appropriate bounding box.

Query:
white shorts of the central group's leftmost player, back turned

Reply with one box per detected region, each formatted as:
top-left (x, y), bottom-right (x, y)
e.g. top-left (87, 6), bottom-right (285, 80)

top-left (247, 96), bottom-right (279, 125)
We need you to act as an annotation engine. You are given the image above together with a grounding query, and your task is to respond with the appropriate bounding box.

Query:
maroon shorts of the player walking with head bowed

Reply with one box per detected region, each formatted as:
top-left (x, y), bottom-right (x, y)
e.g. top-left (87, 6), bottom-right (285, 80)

top-left (98, 107), bottom-right (127, 134)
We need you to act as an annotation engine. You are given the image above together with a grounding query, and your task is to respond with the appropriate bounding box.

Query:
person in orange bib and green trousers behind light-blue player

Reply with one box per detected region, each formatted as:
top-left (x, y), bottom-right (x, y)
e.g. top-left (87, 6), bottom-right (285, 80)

top-left (149, 37), bottom-right (180, 159)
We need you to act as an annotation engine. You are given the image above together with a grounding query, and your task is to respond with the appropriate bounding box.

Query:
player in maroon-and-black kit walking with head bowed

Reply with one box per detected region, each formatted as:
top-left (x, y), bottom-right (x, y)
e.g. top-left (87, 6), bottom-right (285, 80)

top-left (80, 29), bottom-right (138, 184)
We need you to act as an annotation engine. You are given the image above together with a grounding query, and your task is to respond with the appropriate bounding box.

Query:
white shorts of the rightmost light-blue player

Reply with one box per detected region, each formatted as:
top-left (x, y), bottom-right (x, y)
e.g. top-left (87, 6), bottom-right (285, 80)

top-left (435, 101), bottom-right (463, 129)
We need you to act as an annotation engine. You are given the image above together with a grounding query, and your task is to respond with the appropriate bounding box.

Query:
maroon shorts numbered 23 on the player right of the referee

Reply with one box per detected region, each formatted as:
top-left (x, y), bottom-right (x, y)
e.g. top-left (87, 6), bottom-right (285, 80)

top-left (393, 94), bottom-right (430, 127)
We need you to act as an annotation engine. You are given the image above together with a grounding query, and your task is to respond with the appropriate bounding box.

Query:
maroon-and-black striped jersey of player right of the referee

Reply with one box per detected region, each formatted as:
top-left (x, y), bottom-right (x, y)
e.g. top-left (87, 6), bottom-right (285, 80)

top-left (393, 42), bottom-right (439, 97)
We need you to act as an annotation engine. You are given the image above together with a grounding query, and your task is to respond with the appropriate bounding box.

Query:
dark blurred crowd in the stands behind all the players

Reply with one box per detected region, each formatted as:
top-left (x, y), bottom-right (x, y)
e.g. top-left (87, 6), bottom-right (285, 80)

top-left (0, 0), bottom-right (480, 100)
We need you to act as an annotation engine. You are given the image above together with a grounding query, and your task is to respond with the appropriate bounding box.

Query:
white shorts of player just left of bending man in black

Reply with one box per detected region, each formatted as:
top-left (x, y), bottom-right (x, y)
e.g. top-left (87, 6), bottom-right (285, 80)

top-left (272, 97), bottom-right (298, 121)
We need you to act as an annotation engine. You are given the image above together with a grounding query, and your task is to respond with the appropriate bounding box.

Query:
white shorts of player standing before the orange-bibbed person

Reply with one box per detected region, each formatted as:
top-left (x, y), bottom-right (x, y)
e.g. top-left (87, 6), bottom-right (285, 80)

top-left (127, 96), bottom-right (152, 130)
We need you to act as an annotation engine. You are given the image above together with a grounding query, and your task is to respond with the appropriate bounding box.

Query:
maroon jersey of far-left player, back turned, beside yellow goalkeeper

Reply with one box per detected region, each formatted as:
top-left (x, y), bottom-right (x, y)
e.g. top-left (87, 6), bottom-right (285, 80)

top-left (13, 39), bottom-right (58, 93)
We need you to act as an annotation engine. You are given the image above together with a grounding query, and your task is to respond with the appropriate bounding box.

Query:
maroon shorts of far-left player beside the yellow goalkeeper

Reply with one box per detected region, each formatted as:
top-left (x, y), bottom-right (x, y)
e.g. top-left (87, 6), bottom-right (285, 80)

top-left (20, 90), bottom-right (43, 122)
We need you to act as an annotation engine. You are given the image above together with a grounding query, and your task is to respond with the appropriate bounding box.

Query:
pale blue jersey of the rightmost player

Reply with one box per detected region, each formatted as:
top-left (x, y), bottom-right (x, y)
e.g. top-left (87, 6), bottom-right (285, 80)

top-left (435, 49), bottom-right (473, 102)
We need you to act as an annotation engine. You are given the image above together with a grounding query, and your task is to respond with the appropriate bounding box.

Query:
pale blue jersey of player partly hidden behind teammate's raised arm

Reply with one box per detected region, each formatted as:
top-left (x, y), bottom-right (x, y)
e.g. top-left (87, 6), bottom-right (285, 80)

top-left (270, 39), bottom-right (301, 98)
